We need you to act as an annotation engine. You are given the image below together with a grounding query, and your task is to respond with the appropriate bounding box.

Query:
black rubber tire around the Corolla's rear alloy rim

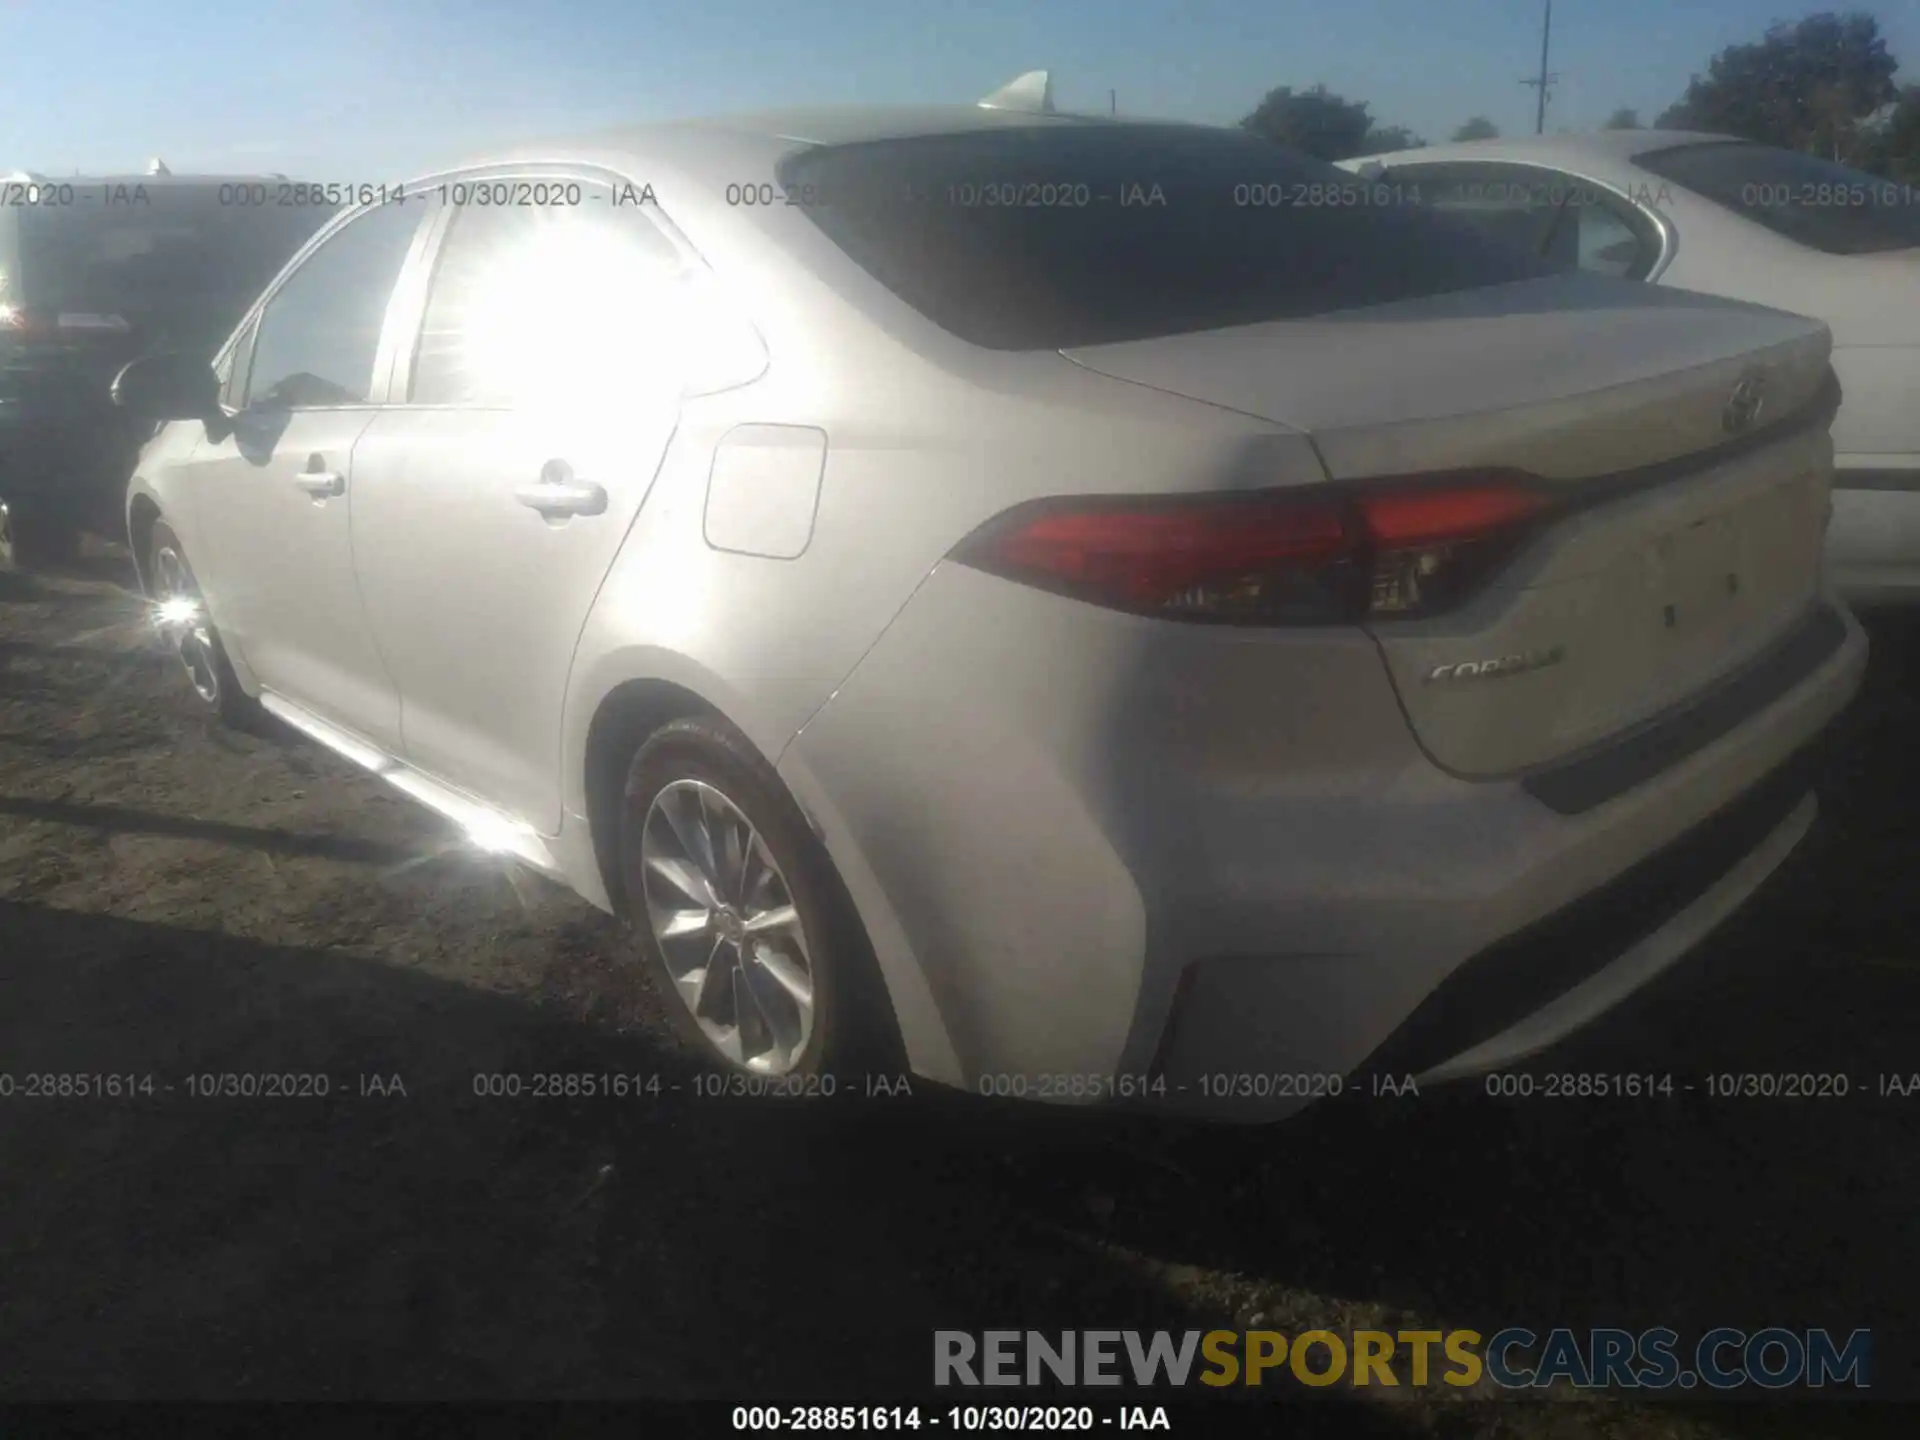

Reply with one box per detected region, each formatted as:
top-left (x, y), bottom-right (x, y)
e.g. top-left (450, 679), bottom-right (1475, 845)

top-left (620, 716), bottom-right (904, 1092)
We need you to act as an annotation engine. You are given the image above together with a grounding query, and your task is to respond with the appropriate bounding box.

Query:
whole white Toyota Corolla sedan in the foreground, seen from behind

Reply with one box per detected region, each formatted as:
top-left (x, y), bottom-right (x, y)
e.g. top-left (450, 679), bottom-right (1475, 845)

top-left (117, 87), bottom-right (1866, 1117)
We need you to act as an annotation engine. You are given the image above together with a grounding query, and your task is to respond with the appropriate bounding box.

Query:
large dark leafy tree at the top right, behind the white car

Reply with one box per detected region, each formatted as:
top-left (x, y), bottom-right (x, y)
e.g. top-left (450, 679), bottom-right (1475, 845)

top-left (1655, 12), bottom-right (1899, 159)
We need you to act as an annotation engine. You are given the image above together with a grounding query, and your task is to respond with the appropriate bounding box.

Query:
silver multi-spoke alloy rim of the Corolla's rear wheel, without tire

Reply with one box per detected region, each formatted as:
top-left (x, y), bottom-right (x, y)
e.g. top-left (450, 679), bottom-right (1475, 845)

top-left (639, 780), bottom-right (814, 1075)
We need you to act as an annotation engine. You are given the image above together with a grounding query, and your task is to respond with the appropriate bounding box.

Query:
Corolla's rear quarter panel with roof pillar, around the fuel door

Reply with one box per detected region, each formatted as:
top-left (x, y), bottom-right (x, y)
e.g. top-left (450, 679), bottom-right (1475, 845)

top-left (561, 131), bottom-right (1321, 814)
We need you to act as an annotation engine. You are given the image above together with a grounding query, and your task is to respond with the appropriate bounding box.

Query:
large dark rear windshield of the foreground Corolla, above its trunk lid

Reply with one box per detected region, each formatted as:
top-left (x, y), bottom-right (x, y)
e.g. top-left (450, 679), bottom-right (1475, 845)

top-left (780, 121), bottom-right (1548, 349)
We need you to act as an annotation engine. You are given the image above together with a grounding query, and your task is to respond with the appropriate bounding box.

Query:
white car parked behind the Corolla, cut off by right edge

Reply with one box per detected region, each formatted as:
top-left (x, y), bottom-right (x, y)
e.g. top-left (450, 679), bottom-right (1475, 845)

top-left (1346, 131), bottom-right (1920, 603)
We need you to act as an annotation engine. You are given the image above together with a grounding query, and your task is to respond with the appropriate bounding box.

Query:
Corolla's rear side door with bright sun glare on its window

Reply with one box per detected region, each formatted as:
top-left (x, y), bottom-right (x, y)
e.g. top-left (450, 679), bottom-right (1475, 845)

top-left (353, 175), bottom-right (689, 833)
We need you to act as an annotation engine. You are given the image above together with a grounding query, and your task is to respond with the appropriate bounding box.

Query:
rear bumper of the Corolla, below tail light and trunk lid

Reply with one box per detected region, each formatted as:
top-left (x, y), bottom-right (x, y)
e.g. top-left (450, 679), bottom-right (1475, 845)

top-left (781, 566), bottom-right (1866, 1119)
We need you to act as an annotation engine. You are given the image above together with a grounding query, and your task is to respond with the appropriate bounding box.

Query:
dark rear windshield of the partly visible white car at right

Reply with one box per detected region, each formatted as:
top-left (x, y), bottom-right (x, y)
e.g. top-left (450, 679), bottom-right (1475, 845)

top-left (1634, 140), bottom-right (1920, 255)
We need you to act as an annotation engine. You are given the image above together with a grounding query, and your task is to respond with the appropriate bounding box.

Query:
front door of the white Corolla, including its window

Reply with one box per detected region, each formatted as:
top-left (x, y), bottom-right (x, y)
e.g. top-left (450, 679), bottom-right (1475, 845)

top-left (188, 200), bottom-right (428, 751)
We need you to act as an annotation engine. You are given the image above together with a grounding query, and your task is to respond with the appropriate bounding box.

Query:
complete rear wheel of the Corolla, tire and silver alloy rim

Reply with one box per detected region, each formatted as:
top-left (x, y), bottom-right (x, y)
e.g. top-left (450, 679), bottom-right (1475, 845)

top-left (620, 718), bottom-right (897, 1077)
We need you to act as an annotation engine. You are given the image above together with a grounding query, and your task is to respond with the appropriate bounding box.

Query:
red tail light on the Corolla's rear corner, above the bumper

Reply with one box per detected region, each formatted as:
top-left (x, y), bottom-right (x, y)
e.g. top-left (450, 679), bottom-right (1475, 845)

top-left (954, 472), bottom-right (1551, 624)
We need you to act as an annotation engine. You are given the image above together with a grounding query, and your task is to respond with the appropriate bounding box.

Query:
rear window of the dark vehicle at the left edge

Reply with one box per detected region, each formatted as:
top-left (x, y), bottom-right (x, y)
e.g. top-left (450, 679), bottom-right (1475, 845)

top-left (0, 180), bottom-right (332, 348)
